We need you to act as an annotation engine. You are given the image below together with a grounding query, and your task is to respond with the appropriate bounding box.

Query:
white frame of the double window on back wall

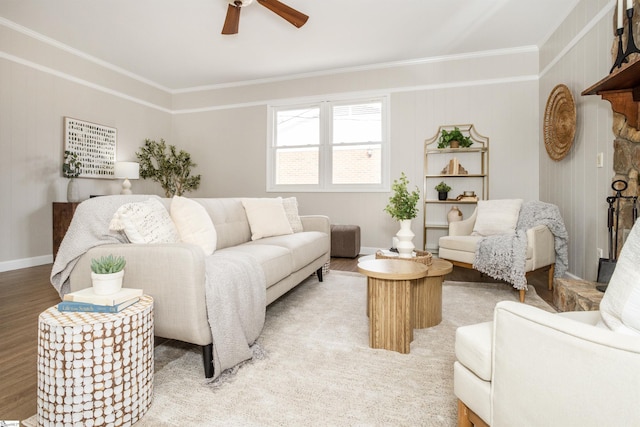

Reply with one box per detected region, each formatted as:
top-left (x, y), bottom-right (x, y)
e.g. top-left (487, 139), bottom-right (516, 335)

top-left (266, 95), bottom-right (391, 192)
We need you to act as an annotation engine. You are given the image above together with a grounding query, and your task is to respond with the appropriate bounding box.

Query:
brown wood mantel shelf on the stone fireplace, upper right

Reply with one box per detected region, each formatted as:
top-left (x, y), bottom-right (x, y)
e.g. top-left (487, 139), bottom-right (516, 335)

top-left (582, 61), bottom-right (640, 129)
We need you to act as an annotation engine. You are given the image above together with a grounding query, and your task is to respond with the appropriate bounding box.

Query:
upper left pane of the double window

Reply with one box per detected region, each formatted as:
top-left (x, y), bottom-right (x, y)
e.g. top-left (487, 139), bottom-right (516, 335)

top-left (276, 107), bottom-right (320, 147)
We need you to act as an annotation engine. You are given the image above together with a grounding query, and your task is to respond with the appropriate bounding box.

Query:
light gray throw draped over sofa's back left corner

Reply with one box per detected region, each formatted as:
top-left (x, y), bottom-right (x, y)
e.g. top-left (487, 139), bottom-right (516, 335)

top-left (51, 194), bottom-right (152, 298)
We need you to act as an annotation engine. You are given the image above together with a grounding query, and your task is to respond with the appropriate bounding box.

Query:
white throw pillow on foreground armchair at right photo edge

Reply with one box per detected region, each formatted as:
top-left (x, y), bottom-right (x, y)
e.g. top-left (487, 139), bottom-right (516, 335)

top-left (598, 222), bottom-right (640, 335)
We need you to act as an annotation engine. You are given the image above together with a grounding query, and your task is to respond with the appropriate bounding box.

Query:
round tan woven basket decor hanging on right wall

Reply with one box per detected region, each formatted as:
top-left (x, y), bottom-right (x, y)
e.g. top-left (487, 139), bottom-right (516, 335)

top-left (544, 84), bottom-right (576, 161)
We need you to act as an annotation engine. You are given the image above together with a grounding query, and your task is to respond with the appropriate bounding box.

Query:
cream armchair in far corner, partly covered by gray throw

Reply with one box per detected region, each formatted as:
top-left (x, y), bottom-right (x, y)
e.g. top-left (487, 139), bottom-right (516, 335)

top-left (438, 202), bottom-right (556, 302)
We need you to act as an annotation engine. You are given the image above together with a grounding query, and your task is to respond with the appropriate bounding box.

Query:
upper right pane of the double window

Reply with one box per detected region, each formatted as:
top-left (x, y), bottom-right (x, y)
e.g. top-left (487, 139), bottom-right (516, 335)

top-left (333, 102), bottom-right (382, 144)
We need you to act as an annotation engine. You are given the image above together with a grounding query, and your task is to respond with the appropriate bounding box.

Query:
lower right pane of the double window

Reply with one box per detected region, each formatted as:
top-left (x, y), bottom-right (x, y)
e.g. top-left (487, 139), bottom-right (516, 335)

top-left (332, 144), bottom-right (382, 184)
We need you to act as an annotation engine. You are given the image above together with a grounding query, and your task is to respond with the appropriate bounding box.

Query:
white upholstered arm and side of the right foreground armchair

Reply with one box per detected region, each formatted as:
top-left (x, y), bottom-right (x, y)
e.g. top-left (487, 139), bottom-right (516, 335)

top-left (491, 302), bottom-right (640, 427)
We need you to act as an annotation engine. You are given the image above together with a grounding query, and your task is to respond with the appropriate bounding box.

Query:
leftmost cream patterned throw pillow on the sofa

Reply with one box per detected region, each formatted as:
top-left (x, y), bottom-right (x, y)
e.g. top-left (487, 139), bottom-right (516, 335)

top-left (109, 197), bottom-right (180, 243)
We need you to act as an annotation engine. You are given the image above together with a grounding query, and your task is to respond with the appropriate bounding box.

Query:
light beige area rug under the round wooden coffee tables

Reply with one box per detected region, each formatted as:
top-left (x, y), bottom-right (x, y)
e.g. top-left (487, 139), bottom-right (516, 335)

top-left (29, 271), bottom-right (555, 427)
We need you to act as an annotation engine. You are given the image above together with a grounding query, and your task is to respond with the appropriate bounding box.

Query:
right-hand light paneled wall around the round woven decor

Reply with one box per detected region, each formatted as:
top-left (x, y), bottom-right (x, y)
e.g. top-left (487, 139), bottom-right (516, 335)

top-left (539, 0), bottom-right (615, 280)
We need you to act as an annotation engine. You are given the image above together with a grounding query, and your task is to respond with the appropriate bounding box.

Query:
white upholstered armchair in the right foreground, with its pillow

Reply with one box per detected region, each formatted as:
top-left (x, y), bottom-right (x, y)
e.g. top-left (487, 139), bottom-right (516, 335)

top-left (454, 219), bottom-right (640, 427)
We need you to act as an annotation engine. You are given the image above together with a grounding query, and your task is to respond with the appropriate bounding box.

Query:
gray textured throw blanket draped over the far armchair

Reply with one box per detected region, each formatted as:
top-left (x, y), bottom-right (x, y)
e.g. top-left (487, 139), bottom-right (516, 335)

top-left (473, 201), bottom-right (569, 289)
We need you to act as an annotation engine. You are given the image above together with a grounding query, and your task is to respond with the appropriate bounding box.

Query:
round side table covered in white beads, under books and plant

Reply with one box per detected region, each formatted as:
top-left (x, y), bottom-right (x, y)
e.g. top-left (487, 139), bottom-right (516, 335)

top-left (37, 295), bottom-right (154, 426)
